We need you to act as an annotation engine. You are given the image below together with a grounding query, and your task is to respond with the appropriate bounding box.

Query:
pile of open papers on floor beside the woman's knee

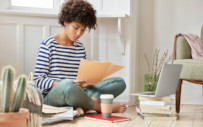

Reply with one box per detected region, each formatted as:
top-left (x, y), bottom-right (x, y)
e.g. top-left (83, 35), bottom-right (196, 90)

top-left (42, 105), bottom-right (78, 125)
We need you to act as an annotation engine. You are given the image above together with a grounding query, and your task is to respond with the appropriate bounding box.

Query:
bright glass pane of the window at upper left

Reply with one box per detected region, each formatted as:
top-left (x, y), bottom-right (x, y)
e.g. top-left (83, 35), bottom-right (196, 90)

top-left (11, 0), bottom-right (54, 9)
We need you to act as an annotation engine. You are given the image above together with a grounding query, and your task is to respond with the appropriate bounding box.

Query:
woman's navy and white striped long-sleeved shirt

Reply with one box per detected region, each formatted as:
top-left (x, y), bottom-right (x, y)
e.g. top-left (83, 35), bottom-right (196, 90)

top-left (34, 36), bottom-right (86, 90)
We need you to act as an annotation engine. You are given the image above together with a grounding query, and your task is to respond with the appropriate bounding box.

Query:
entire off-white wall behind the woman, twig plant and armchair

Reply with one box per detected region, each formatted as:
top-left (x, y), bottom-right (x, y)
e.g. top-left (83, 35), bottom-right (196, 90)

top-left (0, 0), bottom-right (203, 104)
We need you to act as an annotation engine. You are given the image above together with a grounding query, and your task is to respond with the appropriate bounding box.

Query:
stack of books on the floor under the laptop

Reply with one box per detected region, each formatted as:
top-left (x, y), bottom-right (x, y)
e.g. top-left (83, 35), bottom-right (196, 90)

top-left (136, 96), bottom-right (177, 120)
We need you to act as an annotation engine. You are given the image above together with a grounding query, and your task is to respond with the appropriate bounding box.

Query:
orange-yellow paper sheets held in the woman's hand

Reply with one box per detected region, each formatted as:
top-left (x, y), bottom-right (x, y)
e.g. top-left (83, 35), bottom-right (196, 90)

top-left (77, 59), bottom-right (123, 85)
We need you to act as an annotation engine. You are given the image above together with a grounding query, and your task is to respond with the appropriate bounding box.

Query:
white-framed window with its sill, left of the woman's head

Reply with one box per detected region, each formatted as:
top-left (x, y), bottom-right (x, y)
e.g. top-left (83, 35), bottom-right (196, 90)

top-left (0, 0), bottom-right (65, 17)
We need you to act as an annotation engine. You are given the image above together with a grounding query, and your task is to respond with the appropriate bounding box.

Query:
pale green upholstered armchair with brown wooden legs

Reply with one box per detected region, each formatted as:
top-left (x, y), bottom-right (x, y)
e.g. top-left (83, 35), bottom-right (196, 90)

top-left (174, 26), bottom-right (203, 113)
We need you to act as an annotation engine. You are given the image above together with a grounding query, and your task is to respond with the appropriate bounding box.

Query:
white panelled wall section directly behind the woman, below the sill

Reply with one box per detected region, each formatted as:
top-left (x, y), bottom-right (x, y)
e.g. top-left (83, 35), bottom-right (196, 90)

top-left (0, 0), bottom-right (139, 104)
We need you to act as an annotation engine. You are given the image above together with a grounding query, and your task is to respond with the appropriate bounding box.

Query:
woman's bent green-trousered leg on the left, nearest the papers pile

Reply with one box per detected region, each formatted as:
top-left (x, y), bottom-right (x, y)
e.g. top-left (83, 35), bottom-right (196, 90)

top-left (44, 79), bottom-right (94, 110)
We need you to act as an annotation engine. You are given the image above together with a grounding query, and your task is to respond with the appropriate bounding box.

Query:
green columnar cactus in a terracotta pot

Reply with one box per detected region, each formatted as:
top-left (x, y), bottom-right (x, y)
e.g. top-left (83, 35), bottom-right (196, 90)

top-left (0, 66), bottom-right (29, 127)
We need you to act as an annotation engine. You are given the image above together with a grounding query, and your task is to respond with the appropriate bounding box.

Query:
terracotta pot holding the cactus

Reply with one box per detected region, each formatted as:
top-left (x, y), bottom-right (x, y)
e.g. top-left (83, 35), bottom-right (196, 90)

top-left (0, 108), bottom-right (29, 127)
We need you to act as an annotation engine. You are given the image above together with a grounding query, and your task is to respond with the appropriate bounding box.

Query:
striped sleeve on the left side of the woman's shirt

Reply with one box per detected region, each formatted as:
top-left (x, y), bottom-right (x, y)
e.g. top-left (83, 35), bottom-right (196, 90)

top-left (34, 43), bottom-right (54, 89)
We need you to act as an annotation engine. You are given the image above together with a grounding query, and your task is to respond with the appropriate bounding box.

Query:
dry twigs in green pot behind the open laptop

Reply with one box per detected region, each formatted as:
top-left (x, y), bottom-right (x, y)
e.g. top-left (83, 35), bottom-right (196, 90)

top-left (144, 49), bottom-right (172, 92)
